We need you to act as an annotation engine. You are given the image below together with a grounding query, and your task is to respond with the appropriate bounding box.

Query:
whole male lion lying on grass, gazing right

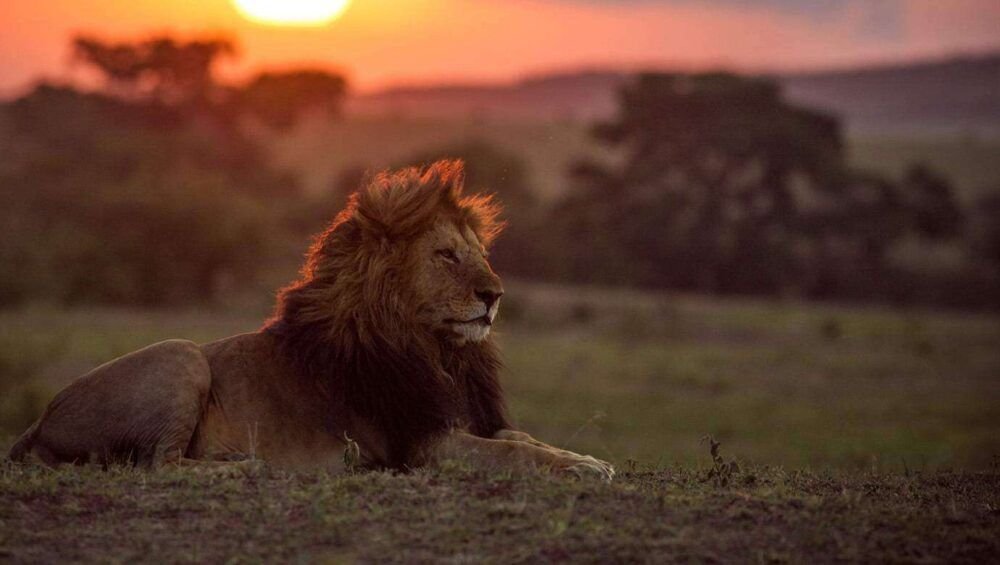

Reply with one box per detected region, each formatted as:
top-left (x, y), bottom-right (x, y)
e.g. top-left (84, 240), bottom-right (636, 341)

top-left (10, 161), bottom-right (614, 479)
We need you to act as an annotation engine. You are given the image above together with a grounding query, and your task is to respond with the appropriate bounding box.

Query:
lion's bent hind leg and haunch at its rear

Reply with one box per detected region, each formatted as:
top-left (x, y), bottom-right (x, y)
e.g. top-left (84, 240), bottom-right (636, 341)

top-left (10, 340), bottom-right (211, 467)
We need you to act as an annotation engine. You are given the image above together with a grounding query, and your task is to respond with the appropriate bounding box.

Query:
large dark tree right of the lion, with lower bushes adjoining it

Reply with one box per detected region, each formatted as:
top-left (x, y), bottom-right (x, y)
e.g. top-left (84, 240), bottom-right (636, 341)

top-left (546, 74), bottom-right (963, 299)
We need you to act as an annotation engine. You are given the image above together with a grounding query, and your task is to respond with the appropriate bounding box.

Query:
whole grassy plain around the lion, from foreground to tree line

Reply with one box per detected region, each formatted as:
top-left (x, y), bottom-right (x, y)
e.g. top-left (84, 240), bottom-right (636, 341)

top-left (0, 282), bottom-right (1000, 563)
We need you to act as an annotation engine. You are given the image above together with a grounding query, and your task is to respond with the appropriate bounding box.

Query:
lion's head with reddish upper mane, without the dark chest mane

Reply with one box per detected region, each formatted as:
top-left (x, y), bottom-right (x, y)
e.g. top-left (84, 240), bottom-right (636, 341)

top-left (279, 161), bottom-right (503, 345)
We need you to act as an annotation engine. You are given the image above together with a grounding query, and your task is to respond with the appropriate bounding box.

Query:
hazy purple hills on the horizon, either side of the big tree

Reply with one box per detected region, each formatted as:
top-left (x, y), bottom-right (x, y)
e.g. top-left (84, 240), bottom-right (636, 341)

top-left (349, 52), bottom-right (1000, 134)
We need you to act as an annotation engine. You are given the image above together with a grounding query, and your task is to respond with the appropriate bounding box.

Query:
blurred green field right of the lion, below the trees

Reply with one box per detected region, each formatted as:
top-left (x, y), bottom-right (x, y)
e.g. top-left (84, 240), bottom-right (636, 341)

top-left (502, 287), bottom-right (1000, 470)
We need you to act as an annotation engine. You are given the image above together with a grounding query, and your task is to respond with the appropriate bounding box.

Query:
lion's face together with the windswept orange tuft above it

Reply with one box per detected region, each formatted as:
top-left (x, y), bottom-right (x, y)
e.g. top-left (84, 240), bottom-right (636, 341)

top-left (362, 161), bottom-right (503, 345)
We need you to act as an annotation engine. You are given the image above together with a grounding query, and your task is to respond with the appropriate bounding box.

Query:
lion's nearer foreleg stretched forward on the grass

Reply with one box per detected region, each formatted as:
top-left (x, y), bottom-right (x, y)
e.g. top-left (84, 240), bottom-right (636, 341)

top-left (427, 431), bottom-right (613, 480)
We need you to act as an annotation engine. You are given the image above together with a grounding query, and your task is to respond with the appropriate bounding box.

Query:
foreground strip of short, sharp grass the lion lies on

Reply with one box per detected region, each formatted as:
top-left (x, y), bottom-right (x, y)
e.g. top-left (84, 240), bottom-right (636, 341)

top-left (0, 458), bottom-right (1000, 563)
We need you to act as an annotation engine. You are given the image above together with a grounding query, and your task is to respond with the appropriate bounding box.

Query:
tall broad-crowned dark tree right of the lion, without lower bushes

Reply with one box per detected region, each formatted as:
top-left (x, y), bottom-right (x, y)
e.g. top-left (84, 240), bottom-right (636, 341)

top-left (557, 74), bottom-right (842, 292)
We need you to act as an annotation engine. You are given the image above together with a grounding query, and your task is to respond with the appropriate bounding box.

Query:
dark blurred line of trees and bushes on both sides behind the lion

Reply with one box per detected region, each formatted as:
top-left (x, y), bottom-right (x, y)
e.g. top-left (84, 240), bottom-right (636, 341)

top-left (0, 37), bottom-right (1000, 307)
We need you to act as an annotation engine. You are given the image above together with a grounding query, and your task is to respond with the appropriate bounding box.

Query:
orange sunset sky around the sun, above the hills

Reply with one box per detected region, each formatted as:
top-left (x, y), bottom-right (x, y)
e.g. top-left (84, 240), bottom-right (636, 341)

top-left (0, 0), bottom-right (1000, 94)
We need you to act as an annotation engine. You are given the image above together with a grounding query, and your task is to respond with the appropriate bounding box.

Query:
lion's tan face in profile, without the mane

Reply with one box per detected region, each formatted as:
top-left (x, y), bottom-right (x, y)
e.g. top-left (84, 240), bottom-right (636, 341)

top-left (410, 219), bottom-right (503, 345)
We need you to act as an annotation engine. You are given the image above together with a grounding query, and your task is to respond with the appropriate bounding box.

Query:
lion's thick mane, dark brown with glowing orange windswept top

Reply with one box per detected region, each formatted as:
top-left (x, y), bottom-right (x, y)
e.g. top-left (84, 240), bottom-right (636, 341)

top-left (264, 161), bottom-right (507, 468)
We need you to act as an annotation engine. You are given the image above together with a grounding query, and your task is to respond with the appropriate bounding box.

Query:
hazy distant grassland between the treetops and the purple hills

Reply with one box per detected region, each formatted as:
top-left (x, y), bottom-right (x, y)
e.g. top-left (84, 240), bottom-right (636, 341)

top-left (270, 116), bottom-right (1000, 203)
